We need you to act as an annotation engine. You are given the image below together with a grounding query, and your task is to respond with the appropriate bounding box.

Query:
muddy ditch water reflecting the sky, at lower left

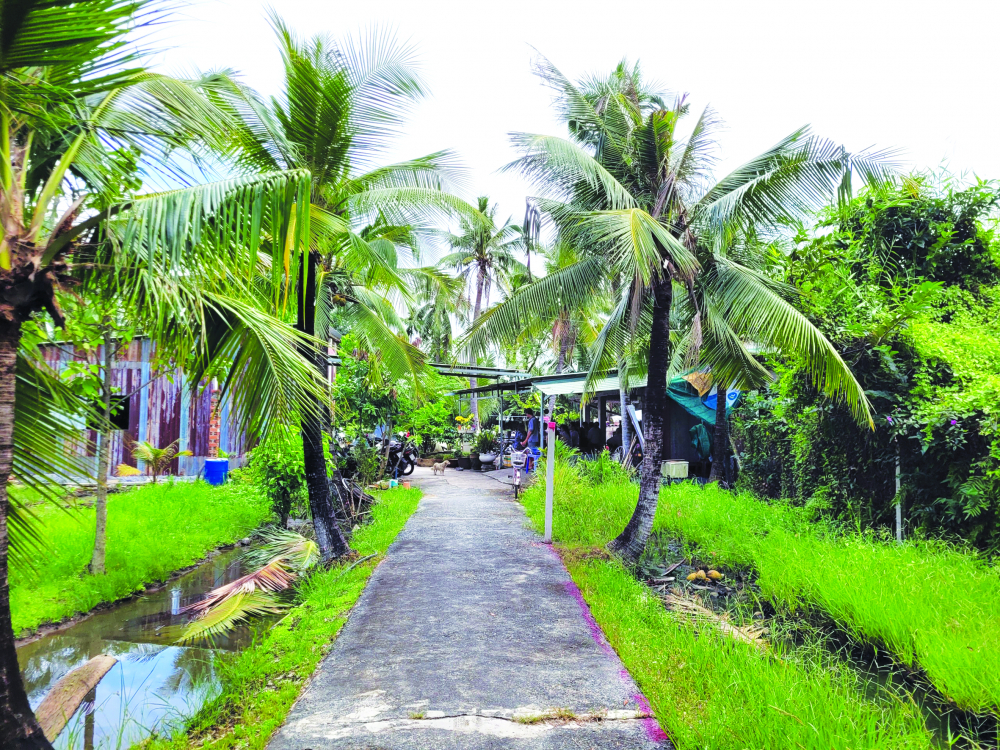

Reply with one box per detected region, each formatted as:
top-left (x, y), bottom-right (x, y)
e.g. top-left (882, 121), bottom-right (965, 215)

top-left (17, 550), bottom-right (259, 750)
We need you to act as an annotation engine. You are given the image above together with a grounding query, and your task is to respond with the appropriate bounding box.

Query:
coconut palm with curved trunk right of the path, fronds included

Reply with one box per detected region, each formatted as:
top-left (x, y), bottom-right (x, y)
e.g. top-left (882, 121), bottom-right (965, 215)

top-left (470, 59), bottom-right (884, 561)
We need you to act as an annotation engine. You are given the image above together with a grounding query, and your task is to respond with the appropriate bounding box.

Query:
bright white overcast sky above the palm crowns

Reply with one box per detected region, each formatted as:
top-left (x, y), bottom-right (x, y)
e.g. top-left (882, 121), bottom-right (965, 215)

top-left (158, 0), bottom-right (1000, 247)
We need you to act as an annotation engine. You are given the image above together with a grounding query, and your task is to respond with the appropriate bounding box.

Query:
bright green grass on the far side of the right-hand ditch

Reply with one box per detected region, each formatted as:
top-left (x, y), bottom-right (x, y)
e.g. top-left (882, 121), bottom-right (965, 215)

top-left (655, 484), bottom-right (1000, 712)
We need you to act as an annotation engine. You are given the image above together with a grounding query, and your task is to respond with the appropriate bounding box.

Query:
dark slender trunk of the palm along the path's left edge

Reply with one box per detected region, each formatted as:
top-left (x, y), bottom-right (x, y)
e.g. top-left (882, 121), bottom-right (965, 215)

top-left (296, 253), bottom-right (351, 562)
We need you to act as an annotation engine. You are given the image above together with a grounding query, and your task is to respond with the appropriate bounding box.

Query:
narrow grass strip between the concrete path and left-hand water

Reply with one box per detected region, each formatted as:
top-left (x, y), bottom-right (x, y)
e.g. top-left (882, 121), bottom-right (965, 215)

top-left (145, 488), bottom-right (421, 750)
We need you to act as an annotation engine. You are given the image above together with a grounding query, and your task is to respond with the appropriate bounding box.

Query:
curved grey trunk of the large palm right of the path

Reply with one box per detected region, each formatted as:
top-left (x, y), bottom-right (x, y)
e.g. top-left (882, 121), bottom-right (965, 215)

top-left (608, 278), bottom-right (673, 564)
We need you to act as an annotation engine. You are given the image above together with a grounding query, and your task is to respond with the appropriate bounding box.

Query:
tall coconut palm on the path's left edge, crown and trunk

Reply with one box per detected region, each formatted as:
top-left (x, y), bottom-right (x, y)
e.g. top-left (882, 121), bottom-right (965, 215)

top-left (213, 14), bottom-right (478, 561)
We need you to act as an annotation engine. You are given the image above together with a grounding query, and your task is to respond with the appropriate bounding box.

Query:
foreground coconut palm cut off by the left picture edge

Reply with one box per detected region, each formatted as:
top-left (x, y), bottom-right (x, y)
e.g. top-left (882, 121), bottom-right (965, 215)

top-left (0, 0), bottom-right (332, 748)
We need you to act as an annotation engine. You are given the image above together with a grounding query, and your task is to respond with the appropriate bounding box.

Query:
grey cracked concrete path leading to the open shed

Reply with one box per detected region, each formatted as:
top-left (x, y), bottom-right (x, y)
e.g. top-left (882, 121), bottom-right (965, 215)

top-left (268, 468), bottom-right (670, 750)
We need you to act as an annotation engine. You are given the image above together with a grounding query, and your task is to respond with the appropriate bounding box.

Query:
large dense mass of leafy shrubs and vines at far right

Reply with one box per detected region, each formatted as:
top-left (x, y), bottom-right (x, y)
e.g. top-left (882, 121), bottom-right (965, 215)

top-left (734, 177), bottom-right (1000, 551)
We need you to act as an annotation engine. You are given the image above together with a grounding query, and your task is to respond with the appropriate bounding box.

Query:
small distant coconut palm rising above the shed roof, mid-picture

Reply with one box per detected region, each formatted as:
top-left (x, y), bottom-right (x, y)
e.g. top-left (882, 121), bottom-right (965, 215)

top-left (438, 195), bottom-right (528, 426)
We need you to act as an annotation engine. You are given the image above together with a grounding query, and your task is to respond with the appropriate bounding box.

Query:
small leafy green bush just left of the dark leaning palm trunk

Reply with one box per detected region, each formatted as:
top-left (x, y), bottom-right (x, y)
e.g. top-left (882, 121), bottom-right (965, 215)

top-left (250, 424), bottom-right (307, 524)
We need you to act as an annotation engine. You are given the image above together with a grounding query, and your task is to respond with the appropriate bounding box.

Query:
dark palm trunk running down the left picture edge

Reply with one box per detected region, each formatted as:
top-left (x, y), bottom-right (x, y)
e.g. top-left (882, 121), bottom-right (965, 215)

top-left (0, 323), bottom-right (52, 750)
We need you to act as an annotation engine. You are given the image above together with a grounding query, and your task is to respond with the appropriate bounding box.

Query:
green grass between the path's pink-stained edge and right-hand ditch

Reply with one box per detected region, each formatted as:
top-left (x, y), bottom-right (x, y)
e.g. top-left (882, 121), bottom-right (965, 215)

top-left (524, 465), bottom-right (931, 750)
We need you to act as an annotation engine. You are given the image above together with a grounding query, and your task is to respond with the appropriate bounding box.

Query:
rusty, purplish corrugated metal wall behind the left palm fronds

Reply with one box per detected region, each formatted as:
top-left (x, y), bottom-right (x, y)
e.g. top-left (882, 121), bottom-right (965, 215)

top-left (42, 338), bottom-right (246, 476)
